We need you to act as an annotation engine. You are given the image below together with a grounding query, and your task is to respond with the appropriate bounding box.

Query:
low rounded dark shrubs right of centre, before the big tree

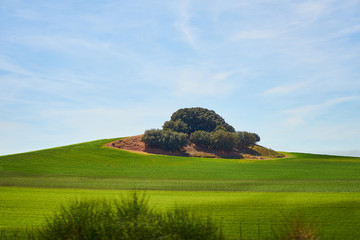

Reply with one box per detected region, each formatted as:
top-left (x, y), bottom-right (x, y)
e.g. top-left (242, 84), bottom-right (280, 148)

top-left (190, 130), bottom-right (260, 151)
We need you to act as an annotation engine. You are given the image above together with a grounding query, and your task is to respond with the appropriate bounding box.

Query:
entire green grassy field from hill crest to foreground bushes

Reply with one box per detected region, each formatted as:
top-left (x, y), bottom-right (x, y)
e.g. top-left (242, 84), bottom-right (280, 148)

top-left (0, 139), bottom-right (360, 239)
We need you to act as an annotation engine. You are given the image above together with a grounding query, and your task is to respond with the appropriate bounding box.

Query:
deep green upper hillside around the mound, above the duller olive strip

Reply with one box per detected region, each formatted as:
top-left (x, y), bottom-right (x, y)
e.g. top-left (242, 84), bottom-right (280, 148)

top-left (0, 139), bottom-right (360, 181)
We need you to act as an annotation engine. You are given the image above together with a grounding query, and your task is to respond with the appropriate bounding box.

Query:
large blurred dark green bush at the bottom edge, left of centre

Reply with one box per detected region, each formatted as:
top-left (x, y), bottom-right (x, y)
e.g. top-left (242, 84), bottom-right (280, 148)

top-left (39, 194), bottom-right (224, 240)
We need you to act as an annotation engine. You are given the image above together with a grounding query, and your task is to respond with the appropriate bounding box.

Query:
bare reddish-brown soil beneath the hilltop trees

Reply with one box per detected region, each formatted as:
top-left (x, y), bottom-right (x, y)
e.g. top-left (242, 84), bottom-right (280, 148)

top-left (105, 135), bottom-right (264, 159)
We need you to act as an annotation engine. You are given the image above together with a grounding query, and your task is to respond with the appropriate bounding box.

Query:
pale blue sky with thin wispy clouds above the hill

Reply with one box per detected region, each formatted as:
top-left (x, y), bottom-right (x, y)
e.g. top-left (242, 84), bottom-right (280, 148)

top-left (0, 0), bottom-right (360, 156)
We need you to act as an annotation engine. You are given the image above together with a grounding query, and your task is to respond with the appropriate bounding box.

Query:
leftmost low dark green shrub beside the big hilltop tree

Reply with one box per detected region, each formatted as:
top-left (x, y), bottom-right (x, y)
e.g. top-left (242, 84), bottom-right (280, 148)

top-left (142, 129), bottom-right (189, 151)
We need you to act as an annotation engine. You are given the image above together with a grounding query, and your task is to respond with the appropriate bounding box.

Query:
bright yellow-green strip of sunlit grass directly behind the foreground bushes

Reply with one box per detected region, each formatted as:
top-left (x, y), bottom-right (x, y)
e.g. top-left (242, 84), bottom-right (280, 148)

top-left (0, 187), bottom-right (360, 239)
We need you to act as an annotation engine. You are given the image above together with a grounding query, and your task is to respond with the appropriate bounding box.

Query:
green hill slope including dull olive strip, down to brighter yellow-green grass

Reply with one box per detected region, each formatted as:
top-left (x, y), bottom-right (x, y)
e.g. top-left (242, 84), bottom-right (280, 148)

top-left (0, 139), bottom-right (360, 192)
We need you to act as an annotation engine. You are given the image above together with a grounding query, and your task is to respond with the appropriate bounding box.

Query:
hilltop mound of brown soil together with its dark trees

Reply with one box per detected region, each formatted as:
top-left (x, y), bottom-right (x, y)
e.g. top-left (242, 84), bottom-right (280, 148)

top-left (136, 107), bottom-right (284, 159)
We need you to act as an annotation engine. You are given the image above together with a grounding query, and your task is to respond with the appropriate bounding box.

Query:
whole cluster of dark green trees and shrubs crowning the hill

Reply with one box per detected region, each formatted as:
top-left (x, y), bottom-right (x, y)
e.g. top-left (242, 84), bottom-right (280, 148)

top-left (142, 107), bottom-right (260, 151)
